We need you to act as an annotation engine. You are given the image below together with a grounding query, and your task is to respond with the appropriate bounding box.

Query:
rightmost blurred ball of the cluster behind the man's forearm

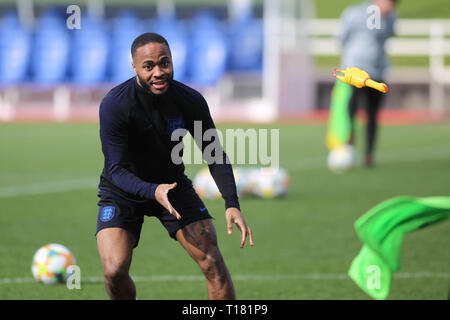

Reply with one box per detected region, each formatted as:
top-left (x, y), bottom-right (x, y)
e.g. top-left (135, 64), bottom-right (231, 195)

top-left (250, 168), bottom-right (290, 199)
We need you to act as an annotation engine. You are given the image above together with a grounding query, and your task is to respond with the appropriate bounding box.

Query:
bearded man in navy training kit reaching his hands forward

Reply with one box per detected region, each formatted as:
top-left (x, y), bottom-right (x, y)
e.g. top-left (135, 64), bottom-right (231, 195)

top-left (96, 33), bottom-right (253, 299)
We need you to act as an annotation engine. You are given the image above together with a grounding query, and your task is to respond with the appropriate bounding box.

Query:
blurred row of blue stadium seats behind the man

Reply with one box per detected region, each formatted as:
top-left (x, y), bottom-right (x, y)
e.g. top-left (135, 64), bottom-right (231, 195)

top-left (0, 9), bottom-right (263, 86)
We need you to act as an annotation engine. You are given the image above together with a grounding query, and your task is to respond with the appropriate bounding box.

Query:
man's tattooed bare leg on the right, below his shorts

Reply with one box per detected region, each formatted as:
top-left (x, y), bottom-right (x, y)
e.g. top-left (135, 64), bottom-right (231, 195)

top-left (176, 219), bottom-right (236, 300)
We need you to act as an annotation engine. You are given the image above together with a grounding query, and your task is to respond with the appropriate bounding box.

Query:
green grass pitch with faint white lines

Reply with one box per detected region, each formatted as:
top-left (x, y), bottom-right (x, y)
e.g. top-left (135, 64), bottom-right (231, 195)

top-left (0, 124), bottom-right (450, 300)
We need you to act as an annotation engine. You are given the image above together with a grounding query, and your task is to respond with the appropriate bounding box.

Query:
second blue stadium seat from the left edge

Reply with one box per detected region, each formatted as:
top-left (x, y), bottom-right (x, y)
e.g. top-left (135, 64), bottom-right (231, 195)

top-left (31, 10), bottom-right (69, 83)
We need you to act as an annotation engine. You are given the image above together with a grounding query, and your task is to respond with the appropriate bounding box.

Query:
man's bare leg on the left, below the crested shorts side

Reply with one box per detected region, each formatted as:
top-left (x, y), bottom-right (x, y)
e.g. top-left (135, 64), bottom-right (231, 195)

top-left (97, 228), bottom-right (136, 300)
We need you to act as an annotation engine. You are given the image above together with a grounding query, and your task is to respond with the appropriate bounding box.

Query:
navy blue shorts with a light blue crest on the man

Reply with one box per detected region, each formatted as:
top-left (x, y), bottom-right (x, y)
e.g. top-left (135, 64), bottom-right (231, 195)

top-left (95, 184), bottom-right (212, 247)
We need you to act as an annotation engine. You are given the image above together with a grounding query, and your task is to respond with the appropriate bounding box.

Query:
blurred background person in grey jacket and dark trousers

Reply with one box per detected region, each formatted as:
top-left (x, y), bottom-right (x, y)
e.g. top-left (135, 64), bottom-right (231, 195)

top-left (339, 0), bottom-right (397, 167)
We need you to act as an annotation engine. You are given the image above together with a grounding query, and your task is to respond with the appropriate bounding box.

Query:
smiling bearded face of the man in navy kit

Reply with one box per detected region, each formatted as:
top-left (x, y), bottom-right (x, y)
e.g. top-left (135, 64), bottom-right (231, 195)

top-left (132, 42), bottom-right (173, 95)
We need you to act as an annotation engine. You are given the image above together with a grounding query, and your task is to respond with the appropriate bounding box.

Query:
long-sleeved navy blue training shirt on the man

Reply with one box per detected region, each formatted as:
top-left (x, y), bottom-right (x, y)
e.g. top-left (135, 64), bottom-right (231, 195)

top-left (99, 77), bottom-right (239, 209)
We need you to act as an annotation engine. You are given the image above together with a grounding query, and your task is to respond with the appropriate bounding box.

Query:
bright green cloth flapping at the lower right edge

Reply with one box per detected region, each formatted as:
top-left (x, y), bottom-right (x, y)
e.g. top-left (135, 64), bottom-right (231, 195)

top-left (348, 197), bottom-right (450, 299)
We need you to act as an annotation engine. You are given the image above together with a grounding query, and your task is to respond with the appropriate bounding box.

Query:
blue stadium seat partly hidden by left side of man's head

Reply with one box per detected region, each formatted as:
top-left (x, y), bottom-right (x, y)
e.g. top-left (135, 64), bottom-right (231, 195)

top-left (108, 10), bottom-right (143, 83)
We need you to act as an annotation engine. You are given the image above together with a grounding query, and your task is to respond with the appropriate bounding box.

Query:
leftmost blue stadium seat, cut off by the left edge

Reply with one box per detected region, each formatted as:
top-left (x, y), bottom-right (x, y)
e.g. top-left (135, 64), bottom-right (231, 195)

top-left (0, 12), bottom-right (30, 84)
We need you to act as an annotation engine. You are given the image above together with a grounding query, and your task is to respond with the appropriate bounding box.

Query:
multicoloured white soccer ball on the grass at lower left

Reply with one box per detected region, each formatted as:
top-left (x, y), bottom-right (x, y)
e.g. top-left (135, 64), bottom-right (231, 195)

top-left (31, 243), bottom-right (75, 284)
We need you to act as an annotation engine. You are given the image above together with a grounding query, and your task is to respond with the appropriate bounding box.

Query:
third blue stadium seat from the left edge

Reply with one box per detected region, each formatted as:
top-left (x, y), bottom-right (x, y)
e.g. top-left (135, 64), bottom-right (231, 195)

top-left (70, 16), bottom-right (108, 84)
